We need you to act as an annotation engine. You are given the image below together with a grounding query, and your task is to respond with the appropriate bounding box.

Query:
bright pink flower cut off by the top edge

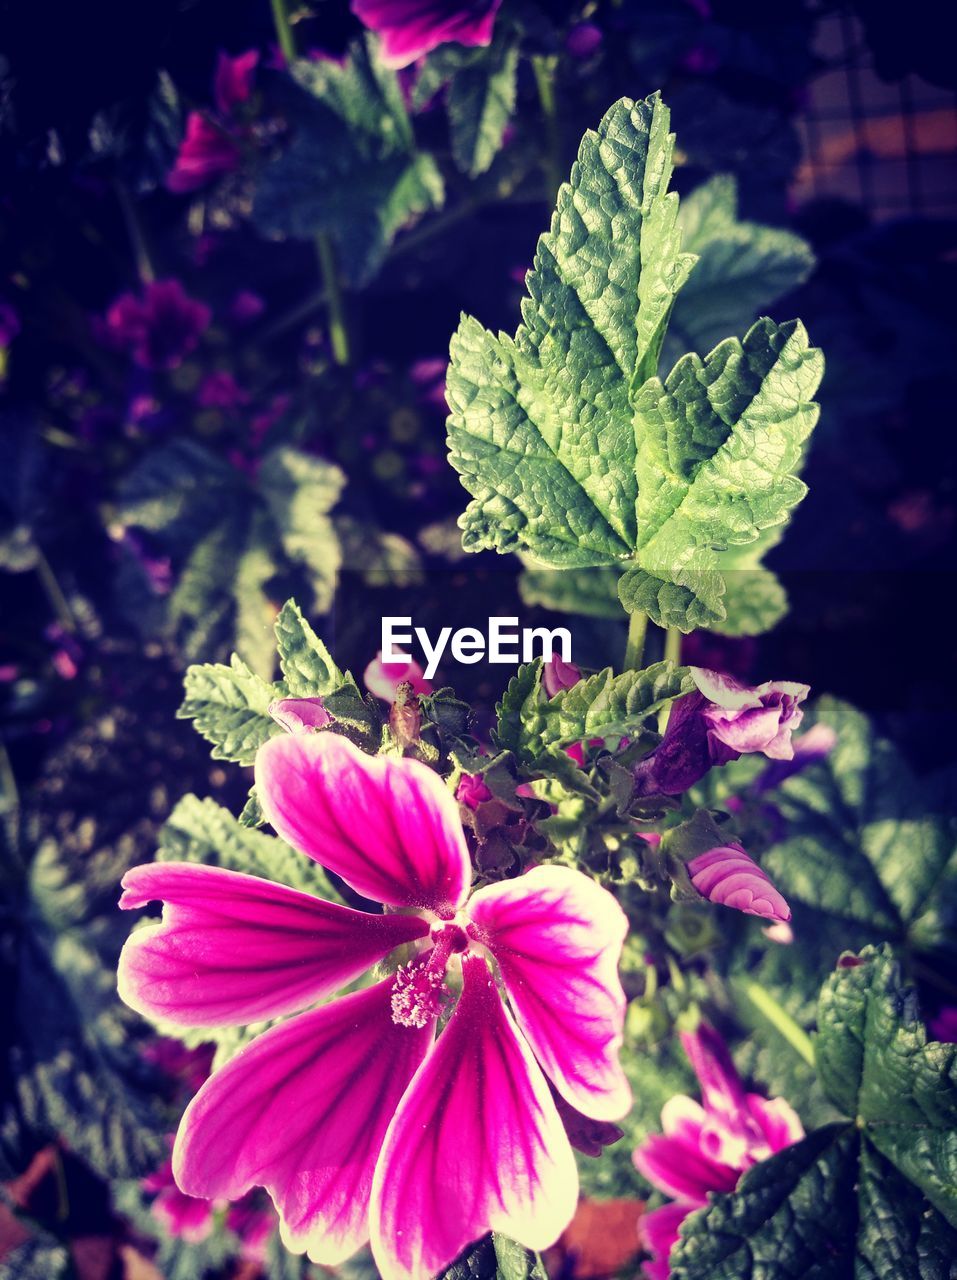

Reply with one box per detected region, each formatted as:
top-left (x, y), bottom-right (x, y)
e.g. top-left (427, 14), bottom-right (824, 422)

top-left (352, 0), bottom-right (502, 67)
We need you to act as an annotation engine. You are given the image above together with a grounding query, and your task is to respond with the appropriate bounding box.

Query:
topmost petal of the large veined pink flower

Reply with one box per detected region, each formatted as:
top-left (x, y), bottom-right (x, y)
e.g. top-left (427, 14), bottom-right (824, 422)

top-left (256, 733), bottom-right (472, 916)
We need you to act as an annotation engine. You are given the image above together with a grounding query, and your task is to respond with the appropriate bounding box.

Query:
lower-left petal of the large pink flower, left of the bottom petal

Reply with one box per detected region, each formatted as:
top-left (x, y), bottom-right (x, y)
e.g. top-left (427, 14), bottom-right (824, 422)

top-left (173, 979), bottom-right (435, 1266)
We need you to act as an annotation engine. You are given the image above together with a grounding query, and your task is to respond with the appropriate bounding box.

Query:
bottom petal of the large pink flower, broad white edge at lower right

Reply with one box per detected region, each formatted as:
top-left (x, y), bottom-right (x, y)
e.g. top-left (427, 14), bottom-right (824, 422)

top-left (371, 955), bottom-right (578, 1280)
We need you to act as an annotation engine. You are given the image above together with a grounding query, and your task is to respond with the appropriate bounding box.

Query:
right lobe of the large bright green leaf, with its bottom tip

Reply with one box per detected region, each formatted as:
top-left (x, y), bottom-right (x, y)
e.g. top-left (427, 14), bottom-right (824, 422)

top-left (619, 320), bottom-right (824, 631)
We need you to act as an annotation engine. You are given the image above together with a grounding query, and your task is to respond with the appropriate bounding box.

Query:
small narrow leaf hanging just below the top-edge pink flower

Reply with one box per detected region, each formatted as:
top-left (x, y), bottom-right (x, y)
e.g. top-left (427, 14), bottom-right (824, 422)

top-left (447, 38), bottom-right (518, 178)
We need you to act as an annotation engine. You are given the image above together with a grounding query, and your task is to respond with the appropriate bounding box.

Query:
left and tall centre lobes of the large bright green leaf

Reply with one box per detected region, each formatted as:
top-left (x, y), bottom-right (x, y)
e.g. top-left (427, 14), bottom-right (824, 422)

top-left (447, 96), bottom-right (693, 568)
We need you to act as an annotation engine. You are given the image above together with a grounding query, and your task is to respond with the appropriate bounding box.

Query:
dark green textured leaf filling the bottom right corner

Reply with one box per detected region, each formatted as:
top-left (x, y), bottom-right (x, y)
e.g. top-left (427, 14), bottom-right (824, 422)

top-left (670, 947), bottom-right (957, 1280)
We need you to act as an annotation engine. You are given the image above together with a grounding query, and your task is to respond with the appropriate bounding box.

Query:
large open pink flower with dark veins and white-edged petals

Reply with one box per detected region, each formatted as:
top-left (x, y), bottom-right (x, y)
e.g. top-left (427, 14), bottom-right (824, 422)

top-left (119, 732), bottom-right (629, 1280)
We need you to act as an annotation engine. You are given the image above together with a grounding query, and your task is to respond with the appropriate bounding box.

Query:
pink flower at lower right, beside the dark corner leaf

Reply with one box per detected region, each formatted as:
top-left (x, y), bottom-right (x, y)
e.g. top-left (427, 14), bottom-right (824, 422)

top-left (635, 1023), bottom-right (803, 1280)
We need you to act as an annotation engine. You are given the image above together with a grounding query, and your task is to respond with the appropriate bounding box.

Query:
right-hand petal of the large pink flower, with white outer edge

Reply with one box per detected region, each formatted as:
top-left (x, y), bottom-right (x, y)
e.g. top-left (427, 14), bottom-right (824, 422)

top-left (467, 867), bottom-right (631, 1120)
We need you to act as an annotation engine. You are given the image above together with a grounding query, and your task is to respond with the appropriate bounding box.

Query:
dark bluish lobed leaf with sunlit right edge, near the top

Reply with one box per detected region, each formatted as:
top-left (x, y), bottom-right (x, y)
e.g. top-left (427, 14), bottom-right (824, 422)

top-left (252, 41), bottom-right (444, 284)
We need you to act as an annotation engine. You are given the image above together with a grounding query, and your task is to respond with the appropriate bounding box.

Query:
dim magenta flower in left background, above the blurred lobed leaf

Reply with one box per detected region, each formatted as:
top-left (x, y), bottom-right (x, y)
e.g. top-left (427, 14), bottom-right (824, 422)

top-left (101, 280), bottom-right (212, 369)
